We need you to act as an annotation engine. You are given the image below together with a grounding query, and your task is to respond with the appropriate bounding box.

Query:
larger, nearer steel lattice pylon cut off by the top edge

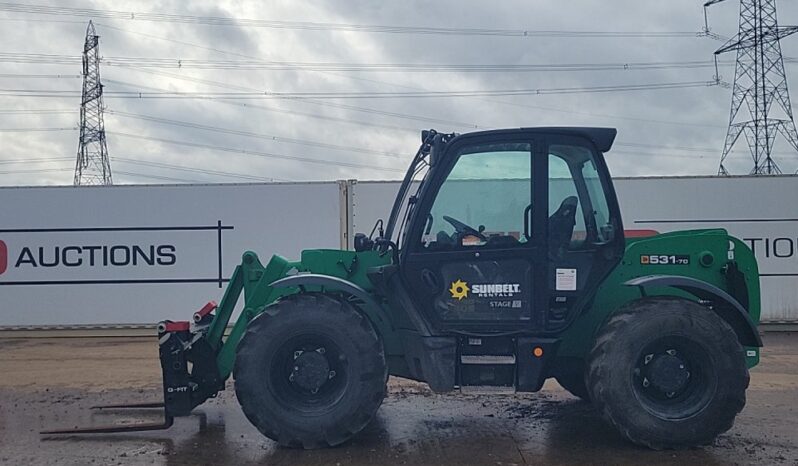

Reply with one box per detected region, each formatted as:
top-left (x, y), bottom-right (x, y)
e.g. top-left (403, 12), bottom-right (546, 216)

top-left (704, 0), bottom-right (798, 175)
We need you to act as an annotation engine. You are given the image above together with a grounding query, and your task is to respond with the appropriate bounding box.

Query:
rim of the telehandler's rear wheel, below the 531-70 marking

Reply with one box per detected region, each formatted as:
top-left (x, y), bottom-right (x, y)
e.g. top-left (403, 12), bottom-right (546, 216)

top-left (631, 335), bottom-right (717, 420)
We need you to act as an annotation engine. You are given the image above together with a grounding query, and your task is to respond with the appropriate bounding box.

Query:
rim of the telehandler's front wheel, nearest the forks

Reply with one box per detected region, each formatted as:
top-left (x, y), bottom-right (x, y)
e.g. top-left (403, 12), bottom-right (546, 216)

top-left (269, 333), bottom-right (347, 414)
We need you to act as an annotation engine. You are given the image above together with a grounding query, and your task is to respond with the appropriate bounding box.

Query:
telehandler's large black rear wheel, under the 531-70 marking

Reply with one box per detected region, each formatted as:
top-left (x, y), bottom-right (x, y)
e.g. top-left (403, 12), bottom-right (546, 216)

top-left (587, 297), bottom-right (749, 450)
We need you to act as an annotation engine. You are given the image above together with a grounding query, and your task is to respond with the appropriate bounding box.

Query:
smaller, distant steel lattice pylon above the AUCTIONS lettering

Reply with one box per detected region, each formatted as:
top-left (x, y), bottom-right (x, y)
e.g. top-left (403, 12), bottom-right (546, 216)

top-left (74, 21), bottom-right (114, 186)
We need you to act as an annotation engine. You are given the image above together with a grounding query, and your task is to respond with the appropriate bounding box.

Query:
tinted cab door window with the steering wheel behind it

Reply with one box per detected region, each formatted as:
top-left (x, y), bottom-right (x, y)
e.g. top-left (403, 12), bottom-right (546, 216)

top-left (421, 143), bottom-right (532, 250)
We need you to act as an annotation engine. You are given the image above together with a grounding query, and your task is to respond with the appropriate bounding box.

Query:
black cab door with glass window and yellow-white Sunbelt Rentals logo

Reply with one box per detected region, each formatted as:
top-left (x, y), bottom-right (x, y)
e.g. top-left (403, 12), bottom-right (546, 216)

top-left (401, 133), bottom-right (548, 331)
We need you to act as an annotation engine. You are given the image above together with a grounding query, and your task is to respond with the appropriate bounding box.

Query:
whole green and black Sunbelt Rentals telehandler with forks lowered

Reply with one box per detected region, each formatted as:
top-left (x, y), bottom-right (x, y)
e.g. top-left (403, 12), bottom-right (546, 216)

top-left (42, 128), bottom-right (762, 449)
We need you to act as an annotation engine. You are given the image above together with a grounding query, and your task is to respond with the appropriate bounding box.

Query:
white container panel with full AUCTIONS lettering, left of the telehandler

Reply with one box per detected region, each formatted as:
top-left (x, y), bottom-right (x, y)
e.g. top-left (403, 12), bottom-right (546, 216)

top-left (0, 182), bottom-right (341, 326)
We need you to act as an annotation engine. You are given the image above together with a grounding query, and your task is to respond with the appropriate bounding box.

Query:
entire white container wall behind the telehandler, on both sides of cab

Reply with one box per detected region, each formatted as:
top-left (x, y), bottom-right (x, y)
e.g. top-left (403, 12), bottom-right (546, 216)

top-left (0, 176), bottom-right (798, 326)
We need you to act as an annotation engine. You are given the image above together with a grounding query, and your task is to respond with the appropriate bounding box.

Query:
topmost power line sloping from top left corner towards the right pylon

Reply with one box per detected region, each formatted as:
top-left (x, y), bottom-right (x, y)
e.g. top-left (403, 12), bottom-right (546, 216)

top-left (0, 3), bottom-right (698, 38)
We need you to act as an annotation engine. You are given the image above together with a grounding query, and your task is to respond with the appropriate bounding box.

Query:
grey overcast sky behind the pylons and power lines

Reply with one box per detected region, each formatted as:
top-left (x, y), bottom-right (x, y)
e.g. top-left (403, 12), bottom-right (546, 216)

top-left (0, 0), bottom-right (798, 185)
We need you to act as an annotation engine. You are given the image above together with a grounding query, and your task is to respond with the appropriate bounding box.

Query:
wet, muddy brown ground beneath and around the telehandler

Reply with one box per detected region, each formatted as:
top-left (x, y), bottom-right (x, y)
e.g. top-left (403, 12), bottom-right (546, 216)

top-left (0, 333), bottom-right (798, 466)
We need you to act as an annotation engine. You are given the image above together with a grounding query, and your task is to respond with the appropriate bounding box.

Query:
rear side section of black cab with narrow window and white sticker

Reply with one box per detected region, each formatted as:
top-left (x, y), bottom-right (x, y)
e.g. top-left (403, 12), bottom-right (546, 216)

top-left (545, 136), bottom-right (624, 332)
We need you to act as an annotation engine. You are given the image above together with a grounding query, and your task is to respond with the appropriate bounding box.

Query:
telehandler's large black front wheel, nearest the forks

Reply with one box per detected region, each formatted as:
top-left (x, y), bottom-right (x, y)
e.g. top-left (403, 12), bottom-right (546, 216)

top-left (234, 293), bottom-right (387, 449)
